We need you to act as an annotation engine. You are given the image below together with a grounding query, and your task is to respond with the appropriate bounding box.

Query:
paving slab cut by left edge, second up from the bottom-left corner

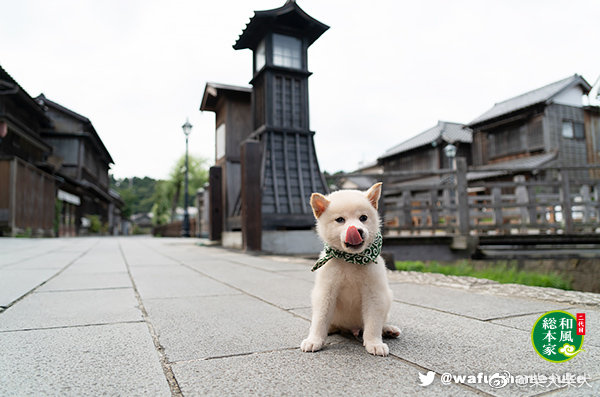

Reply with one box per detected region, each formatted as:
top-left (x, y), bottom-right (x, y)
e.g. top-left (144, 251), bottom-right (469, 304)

top-left (0, 288), bottom-right (142, 331)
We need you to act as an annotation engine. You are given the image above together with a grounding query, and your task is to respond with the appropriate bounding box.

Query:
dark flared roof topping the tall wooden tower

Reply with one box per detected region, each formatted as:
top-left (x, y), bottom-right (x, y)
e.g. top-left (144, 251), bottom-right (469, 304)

top-left (233, 0), bottom-right (329, 50)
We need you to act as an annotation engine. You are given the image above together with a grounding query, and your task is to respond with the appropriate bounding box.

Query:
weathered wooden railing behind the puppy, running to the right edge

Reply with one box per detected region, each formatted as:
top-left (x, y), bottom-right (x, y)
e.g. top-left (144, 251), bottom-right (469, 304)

top-left (368, 159), bottom-right (600, 236)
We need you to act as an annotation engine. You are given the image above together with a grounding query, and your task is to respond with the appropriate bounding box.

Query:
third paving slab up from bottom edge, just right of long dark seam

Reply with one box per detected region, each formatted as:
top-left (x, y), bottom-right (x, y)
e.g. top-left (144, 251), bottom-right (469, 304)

top-left (131, 265), bottom-right (240, 299)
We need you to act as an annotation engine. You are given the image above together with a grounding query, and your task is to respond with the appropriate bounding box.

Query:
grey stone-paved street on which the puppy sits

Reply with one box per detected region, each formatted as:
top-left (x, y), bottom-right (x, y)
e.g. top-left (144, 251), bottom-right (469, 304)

top-left (0, 237), bottom-right (600, 396)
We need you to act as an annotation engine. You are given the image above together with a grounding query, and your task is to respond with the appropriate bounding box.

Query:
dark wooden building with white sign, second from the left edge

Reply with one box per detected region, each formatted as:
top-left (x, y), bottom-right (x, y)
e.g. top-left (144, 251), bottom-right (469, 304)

top-left (36, 94), bottom-right (123, 236)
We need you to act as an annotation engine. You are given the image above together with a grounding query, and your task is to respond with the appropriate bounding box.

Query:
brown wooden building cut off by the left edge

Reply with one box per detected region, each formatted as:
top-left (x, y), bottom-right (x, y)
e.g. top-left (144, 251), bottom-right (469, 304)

top-left (0, 67), bottom-right (58, 236)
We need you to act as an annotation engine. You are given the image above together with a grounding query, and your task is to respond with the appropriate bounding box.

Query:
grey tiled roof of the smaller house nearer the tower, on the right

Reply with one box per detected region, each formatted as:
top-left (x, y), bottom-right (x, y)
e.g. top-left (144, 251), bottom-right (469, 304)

top-left (380, 121), bottom-right (473, 158)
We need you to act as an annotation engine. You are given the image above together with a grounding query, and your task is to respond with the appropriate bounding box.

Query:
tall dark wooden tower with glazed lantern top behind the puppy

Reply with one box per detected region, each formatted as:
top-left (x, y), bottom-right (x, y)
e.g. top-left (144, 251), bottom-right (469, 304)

top-left (233, 0), bottom-right (329, 230)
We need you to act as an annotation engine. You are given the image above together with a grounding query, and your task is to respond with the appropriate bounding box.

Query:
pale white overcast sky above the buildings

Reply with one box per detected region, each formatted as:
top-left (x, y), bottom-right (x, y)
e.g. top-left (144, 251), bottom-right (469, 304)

top-left (0, 0), bottom-right (600, 178)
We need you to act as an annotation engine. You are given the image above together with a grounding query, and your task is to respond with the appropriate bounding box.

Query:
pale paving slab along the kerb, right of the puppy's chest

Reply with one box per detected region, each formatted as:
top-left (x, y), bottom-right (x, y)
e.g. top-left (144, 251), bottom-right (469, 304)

top-left (390, 283), bottom-right (568, 320)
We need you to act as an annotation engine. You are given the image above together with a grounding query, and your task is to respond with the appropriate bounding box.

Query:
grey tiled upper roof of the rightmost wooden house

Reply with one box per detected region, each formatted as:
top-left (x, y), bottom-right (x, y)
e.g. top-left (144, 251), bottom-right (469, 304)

top-left (468, 74), bottom-right (591, 127)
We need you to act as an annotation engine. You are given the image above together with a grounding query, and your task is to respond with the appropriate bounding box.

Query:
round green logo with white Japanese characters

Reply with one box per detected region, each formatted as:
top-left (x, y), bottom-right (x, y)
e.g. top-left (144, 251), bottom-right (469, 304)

top-left (531, 310), bottom-right (583, 363)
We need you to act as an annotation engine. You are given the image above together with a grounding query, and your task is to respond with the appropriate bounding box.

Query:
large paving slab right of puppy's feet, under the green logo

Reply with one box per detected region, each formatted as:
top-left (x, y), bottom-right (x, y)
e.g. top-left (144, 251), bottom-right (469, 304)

top-left (388, 302), bottom-right (600, 396)
